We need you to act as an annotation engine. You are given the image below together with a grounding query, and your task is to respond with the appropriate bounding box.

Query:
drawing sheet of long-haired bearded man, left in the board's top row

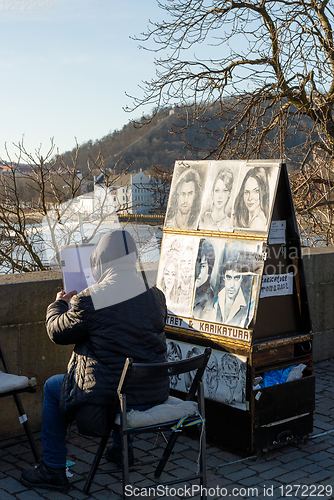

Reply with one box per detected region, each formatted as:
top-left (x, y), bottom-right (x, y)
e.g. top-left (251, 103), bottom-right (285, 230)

top-left (165, 162), bottom-right (207, 229)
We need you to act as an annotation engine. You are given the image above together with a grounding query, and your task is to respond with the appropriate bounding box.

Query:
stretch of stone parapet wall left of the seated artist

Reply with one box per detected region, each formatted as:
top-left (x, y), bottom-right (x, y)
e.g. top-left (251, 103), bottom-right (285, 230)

top-left (0, 271), bottom-right (73, 439)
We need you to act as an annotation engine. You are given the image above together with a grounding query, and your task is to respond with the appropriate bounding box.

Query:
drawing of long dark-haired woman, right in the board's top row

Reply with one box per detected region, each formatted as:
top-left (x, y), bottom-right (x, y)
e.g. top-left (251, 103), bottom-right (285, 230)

top-left (233, 163), bottom-right (279, 231)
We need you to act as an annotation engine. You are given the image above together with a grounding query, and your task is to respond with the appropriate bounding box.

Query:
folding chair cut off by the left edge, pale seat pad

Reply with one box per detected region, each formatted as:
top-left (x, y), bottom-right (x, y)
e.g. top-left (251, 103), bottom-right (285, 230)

top-left (0, 342), bottom-right (40, 462)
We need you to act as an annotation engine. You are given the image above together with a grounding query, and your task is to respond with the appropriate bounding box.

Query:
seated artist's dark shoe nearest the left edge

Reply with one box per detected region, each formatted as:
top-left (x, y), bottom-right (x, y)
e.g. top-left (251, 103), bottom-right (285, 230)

top-left (20, 462), bottom-right (70, 491)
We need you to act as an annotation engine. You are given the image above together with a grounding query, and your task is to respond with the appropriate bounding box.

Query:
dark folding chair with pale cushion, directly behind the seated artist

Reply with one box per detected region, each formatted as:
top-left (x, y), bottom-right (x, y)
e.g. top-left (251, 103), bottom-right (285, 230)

top-left (83, 348), bottom-right (211, 500)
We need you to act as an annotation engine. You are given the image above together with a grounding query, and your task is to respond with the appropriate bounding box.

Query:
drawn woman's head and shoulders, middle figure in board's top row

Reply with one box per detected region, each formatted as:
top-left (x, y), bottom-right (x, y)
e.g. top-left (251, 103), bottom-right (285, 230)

top-left (199, 167), bottom-right (234, 231)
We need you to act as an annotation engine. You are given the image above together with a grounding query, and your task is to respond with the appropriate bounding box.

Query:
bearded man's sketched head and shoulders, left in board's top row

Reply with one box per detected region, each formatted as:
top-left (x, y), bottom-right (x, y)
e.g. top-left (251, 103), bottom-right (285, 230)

top-left (165, 168), bottom-right (202, 229)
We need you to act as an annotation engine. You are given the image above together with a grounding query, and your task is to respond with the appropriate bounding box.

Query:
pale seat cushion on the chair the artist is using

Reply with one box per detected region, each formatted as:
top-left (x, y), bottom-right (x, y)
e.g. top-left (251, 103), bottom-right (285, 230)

top-left (116, 396), bottom-right (198, 428)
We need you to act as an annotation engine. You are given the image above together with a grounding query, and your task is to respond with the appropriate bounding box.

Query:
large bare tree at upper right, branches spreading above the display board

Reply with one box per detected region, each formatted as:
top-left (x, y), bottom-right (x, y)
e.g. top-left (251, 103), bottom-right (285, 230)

top-left (129, 0), bottom-right (334, 241)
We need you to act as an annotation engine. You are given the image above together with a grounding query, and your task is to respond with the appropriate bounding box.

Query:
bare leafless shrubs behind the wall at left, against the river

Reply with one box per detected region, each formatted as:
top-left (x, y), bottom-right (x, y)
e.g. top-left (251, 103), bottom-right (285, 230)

top-left (0, 141), bottom-right (136, 274)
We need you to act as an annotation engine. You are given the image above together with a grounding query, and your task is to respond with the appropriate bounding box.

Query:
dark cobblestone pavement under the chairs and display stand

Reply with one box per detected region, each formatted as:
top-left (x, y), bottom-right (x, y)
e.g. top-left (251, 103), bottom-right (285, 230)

top-left (0, 359), bottom-right (334, 500)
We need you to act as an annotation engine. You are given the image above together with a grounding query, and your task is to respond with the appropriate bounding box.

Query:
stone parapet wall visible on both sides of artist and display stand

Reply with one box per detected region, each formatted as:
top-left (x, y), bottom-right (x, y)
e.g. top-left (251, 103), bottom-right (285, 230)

top-left (0, 247), bottom-right (334, 440)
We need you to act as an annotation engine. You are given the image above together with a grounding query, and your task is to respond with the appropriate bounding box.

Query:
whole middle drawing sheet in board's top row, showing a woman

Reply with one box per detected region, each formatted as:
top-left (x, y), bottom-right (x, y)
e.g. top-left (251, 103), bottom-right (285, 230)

top-left (198, 161), bottom-right (242, 231)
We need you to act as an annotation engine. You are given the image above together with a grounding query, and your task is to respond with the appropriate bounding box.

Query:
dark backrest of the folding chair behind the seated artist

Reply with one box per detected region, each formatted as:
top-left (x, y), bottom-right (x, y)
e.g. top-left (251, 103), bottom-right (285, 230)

top-left (117, 347), bottom-right (211, 400)
